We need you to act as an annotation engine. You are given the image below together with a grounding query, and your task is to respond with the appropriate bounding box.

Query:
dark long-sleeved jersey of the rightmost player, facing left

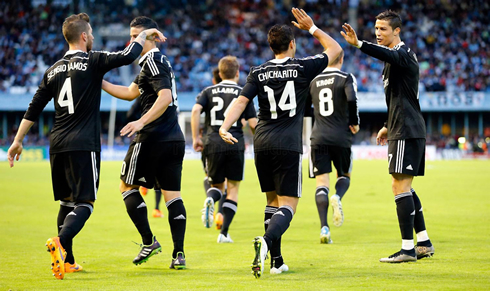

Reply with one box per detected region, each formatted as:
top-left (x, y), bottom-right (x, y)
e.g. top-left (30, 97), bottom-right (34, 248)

top-left (361, 41), bottom-right (426, 140)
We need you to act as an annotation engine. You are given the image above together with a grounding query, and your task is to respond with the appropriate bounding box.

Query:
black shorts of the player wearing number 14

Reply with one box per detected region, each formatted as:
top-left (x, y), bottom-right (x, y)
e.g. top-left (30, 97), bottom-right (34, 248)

top-left (255, 150), bottom-right (303, 198)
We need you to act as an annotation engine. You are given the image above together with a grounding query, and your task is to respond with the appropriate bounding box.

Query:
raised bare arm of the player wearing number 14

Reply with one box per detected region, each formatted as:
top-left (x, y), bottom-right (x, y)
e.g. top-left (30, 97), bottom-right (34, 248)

top-left (292, 8), bottom-right (342, 63)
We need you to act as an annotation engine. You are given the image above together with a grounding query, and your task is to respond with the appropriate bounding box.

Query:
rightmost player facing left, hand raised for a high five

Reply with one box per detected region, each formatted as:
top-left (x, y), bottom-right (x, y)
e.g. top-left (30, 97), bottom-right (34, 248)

top-left (341, 10), bottom-right (434, 263)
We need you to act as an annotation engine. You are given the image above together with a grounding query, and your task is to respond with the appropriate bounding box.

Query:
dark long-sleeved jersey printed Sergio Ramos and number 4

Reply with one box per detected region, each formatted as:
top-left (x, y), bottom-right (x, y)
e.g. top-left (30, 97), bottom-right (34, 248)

top-left (24, 42), bottom-right (142, 153)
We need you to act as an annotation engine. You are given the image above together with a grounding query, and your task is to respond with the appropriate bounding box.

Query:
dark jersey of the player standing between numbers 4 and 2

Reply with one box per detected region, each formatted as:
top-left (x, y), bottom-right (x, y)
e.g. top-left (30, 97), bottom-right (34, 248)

top-left (133, 48), bottom-right (185, 142)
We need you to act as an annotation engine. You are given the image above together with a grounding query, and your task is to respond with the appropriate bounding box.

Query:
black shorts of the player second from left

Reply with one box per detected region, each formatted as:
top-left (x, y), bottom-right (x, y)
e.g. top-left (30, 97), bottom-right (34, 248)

top-left (121, 141), bottom-right (185, 191)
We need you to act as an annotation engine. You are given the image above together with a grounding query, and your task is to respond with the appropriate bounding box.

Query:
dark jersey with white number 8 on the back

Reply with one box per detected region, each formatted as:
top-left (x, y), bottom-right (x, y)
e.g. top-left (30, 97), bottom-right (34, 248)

top-left (310, 68), bottom-right (359, 147)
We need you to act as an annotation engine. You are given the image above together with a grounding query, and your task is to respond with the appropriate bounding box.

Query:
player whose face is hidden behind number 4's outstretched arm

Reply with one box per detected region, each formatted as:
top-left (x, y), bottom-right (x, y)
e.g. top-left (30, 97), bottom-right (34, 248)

top-left (102, 16), bottom-right (187, 269)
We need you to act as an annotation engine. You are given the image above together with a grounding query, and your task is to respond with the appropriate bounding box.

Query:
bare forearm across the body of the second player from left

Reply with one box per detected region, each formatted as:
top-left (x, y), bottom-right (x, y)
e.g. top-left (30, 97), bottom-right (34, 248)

top-left (121, 89), bottom-right (172, 137)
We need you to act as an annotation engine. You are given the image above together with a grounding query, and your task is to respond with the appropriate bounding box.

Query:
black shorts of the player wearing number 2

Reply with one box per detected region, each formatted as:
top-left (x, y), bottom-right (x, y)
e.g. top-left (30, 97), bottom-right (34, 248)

top-left (206, 151), bottom-right (245, 184)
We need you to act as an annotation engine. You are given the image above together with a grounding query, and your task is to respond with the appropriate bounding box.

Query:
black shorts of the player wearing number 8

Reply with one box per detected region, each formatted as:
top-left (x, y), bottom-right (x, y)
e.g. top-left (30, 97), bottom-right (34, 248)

top-left (308, 145), bottom-right (352, 178)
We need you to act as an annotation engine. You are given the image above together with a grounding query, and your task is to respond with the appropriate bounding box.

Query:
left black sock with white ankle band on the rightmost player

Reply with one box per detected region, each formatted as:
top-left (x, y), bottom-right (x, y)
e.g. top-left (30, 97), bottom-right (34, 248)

top-left (395, 192), bottom-right (415, 250)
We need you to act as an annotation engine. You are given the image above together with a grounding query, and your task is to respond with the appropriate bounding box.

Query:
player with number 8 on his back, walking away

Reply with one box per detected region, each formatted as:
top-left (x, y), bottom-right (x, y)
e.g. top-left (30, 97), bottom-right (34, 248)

top-left (309, 51), bottom-right (359, 244)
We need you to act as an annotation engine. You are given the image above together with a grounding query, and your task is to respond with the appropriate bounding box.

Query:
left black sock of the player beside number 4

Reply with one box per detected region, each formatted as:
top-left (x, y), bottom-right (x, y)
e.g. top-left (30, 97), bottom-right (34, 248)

top-left (122, 189), bottom-right (153, 245)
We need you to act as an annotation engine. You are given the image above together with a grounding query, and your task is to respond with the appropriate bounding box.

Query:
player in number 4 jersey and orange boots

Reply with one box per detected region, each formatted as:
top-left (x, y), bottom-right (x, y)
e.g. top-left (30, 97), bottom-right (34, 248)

top-left (7, 13), bottom-right (165, 279)
